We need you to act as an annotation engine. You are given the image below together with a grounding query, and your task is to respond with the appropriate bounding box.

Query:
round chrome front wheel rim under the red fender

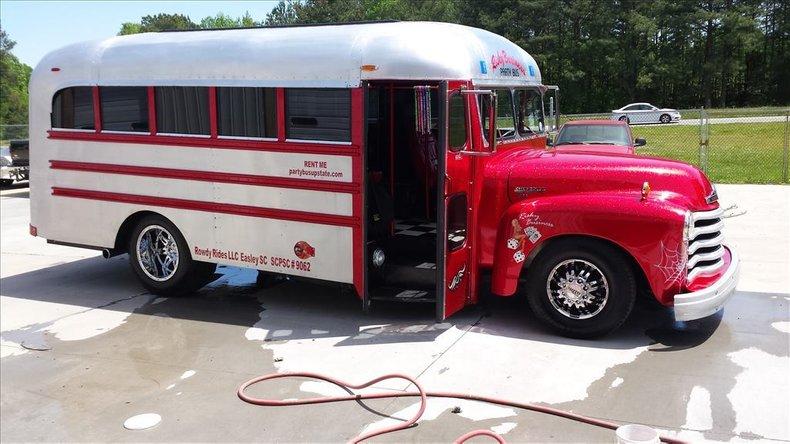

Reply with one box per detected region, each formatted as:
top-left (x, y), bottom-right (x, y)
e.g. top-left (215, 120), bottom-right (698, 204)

top-left (546, 259), bottom-right (609, 319)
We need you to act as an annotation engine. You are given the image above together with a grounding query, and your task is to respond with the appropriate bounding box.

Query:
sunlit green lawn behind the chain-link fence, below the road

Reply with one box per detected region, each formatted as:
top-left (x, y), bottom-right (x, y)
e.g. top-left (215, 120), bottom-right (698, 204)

top-left (631, 122), bottom-right (787, 183)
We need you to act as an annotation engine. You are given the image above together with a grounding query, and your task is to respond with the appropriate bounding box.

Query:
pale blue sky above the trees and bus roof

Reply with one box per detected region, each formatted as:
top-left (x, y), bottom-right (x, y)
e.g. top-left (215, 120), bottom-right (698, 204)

top-left (0, 0), bottom-right (277, 67)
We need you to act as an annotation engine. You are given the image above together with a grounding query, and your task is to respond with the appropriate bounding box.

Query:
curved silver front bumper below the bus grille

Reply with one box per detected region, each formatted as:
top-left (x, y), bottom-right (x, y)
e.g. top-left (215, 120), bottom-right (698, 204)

top-left (675, 248), bottom-right (741, 321)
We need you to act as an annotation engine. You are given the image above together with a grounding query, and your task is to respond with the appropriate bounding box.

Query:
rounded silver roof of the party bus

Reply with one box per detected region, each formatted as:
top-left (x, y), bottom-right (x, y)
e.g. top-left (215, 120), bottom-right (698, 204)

top-left (30, 22), bottom-right (541, 90)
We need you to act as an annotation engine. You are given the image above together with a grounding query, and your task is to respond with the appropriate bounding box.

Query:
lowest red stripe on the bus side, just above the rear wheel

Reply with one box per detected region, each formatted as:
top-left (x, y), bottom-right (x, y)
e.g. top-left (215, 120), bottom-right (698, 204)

top-left (52, 187), bottom-right (359, 228)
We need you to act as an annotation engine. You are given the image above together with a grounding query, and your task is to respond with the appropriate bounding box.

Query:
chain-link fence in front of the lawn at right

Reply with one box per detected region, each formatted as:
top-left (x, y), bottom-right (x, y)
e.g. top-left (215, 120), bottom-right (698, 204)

top-left (562, 108), bottom-right (790, 184)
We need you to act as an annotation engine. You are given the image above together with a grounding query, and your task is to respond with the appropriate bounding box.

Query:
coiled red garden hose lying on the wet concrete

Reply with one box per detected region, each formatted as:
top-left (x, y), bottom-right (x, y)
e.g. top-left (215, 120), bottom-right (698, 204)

top-left (237, 372), bottom-right (685, 444)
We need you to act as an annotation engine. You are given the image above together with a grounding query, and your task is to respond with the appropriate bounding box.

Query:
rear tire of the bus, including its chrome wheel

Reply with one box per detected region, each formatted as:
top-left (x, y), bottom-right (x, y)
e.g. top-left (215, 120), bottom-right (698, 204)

top-left (128, 215), bottom-right (217, 296)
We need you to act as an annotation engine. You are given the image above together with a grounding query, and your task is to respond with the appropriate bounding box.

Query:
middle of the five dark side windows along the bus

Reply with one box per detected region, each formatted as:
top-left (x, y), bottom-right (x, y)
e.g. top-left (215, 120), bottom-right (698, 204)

top-left (156, 86), bottom-right (211, 135)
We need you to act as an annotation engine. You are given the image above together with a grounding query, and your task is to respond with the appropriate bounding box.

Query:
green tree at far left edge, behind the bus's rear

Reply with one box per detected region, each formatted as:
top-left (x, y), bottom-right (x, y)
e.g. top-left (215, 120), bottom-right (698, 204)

top-left (0, 28), bottom-right (32, 125)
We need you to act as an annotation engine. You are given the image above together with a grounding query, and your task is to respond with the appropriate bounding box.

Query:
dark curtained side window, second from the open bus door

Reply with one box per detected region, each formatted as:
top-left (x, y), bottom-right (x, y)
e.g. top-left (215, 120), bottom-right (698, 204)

top-left (217, 88), bottom-right (277, 138)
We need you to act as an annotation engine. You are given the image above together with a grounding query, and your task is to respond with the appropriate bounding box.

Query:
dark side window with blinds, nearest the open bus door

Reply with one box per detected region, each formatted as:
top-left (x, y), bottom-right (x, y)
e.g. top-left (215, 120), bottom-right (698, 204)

top-left (285, 88), bottom-right (351, 142)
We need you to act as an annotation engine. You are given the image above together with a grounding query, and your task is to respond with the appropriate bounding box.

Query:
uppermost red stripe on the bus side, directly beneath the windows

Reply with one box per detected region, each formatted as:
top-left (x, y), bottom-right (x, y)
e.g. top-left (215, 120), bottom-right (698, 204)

top-left (48, 130), bottom-right (360, 157)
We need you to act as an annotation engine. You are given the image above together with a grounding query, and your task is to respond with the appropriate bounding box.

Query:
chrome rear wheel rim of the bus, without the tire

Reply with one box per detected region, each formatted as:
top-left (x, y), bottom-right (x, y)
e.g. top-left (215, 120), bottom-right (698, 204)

top-left (136, 225), bottom-right (178, 282)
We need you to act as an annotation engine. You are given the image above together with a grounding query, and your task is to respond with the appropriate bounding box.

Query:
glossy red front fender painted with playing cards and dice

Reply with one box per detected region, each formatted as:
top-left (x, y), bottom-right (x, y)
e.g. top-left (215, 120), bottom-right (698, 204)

top-left (491, 193), bottom-right (686, 305)
